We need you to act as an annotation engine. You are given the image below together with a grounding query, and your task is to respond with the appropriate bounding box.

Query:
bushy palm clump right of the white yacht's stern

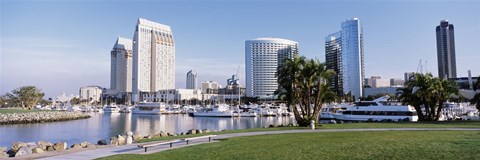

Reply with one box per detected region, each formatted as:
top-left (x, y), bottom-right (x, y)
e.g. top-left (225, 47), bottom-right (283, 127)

top-left (397, 73), bottom-right (458, 121)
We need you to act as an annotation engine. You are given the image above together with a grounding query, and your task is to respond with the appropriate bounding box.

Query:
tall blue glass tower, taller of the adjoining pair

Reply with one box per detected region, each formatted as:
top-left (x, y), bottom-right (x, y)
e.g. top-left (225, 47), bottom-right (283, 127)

top-left (341, 18), bottom-right (365, 99)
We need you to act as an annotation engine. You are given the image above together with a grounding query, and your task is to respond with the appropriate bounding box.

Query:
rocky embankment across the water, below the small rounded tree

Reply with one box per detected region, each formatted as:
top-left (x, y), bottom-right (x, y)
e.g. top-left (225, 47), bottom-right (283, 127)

top-left (0, 111), bottom-right (91, 125)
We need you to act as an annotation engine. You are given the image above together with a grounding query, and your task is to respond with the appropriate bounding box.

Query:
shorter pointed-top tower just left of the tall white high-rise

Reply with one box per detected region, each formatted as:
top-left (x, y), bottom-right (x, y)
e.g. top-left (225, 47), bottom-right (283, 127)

top-left (110, 37), bottom-right (132, 92)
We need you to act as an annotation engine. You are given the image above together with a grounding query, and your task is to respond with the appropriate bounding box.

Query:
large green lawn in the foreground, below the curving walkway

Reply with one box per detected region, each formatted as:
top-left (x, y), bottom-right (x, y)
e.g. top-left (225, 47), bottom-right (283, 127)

top-left (97, 131), bottom-right (480, 160)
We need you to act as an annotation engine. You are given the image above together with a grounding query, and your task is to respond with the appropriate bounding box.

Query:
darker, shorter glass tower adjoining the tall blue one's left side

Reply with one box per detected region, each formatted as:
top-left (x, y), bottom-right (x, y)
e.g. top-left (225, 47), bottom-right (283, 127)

top-left (325, 32), bottom-right (343, 96)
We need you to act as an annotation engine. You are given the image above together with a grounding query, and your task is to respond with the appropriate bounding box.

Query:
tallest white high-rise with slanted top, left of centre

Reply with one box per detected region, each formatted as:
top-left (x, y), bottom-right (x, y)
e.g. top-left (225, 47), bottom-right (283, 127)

top-left (132, 18), bottom-right (175, 101)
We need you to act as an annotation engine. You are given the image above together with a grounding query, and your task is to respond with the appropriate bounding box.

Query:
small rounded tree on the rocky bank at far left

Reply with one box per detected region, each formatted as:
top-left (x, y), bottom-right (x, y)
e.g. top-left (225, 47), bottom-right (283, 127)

top-left (7, 86), bottom-right (45, 110)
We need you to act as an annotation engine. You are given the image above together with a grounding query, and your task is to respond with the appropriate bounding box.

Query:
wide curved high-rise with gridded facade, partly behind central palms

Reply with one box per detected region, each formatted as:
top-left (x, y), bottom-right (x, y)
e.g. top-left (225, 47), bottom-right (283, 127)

top-left (245, 38), bottom-right (298, 97)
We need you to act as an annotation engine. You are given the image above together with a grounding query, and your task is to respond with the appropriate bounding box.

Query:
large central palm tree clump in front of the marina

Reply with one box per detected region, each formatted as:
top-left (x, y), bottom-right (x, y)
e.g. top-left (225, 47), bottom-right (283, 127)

top-left (275, 54), bottom-right (335, 126)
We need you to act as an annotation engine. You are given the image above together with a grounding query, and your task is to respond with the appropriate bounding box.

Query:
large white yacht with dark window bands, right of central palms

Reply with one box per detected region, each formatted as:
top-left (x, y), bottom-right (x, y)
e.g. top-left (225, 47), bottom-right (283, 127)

top-left (332, 96), bottom-right (418, 122)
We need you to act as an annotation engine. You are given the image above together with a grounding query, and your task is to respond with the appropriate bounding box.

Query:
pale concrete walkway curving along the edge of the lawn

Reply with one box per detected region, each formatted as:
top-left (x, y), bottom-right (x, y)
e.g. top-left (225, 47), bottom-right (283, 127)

top-left (37, 128), bottom-right (480, 160)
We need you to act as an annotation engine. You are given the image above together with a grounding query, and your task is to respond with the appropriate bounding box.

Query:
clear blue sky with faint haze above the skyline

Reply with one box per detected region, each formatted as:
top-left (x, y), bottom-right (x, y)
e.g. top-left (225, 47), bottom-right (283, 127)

top-left (0, 0), bottom-right (480, 98)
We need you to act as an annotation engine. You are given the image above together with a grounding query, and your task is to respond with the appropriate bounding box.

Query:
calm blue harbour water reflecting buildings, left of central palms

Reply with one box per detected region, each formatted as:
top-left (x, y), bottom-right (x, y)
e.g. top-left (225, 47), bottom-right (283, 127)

top-left (0, 113), bottom-right (295, 147)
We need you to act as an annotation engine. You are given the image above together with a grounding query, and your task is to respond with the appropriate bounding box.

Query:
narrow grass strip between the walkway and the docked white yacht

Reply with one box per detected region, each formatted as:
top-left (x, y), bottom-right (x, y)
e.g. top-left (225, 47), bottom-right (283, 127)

top-left (318, 121), bottom-right (480, 129)
